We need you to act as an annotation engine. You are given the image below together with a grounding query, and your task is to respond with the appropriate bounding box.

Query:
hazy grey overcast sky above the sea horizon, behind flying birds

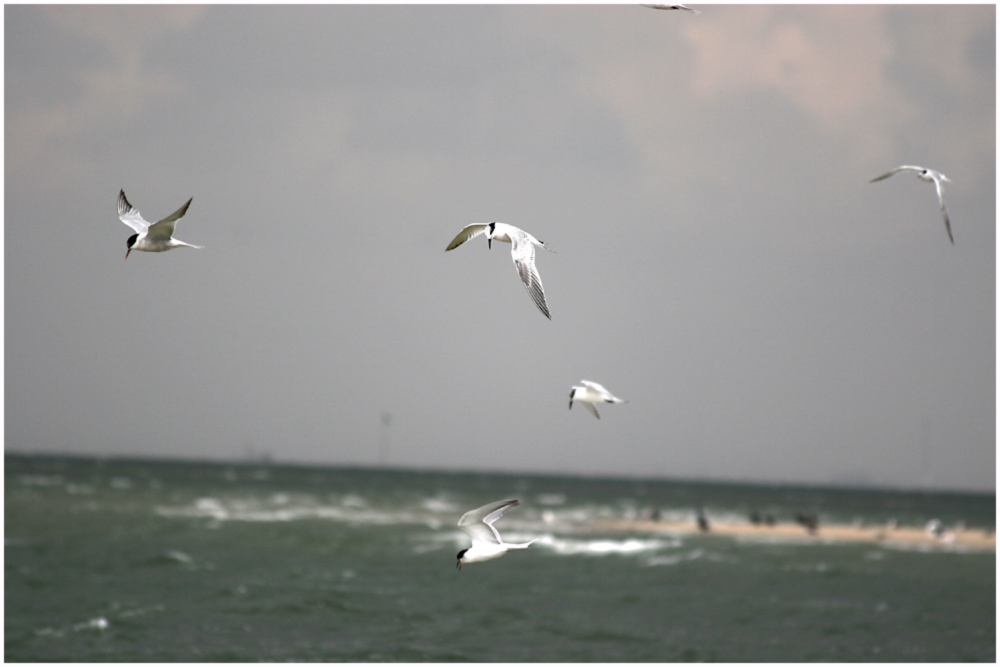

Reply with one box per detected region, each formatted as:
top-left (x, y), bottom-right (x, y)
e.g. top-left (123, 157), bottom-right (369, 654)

top-left (4, 4), bottom-right (996, 492)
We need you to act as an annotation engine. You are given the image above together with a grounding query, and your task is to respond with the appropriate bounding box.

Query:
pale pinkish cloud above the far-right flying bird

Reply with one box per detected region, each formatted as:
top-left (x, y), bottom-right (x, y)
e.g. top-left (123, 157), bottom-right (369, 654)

top-left (685, 5), bottom-right (995, 168)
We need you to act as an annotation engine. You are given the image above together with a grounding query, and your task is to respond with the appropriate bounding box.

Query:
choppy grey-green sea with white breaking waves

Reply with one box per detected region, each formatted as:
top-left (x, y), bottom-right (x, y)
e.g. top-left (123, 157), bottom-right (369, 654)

top-left (4, 453), bottom-right (997, 662)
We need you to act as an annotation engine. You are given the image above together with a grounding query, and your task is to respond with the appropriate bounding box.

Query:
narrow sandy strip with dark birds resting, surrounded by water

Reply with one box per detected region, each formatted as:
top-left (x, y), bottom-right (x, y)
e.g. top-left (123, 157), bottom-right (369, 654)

top-left (591, 519), bottom-right (997, 551)
